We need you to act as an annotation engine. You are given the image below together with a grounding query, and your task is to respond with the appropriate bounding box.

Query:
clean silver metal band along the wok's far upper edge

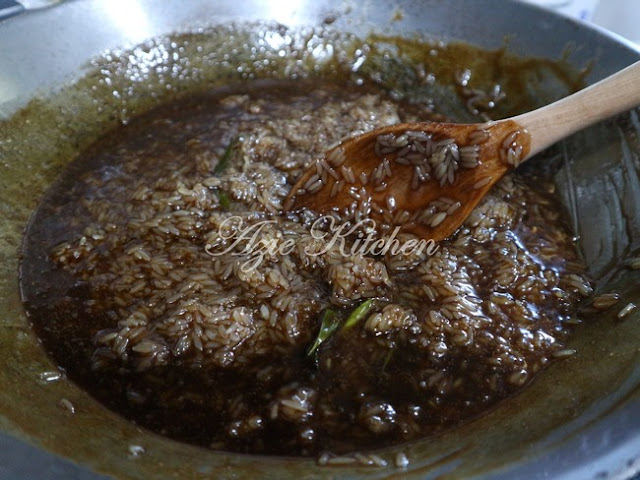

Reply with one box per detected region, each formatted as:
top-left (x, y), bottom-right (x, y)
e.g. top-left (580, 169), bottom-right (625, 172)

top-left (0, 0), bottom-right (637, 115)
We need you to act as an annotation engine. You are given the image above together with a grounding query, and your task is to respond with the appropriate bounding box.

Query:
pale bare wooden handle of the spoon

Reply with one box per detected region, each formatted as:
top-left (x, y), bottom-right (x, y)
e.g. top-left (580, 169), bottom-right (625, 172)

top-left (511, 62), bottom-right (640, 158)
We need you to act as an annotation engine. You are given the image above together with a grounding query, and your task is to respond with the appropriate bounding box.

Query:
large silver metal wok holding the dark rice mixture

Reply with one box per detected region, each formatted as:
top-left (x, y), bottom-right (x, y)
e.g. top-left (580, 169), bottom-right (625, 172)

top-left (0, 0), bottom-right (640, 479)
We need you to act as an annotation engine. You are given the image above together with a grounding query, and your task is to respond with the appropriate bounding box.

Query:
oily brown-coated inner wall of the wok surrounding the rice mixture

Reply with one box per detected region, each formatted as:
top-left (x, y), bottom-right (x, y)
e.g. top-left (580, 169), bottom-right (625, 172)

top-left (0, 17), bottom-right (638, 478)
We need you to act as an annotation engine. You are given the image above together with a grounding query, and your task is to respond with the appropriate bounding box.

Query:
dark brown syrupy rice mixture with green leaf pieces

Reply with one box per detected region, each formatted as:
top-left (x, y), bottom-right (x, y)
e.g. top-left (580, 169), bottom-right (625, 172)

top-left (22, 81), bottom-right (590, 455)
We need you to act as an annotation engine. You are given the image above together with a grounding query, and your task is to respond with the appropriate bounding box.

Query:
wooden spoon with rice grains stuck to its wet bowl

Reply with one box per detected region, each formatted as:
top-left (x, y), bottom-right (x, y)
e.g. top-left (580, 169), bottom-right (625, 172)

top-left (285, 62), bottom-right (640, 241)
